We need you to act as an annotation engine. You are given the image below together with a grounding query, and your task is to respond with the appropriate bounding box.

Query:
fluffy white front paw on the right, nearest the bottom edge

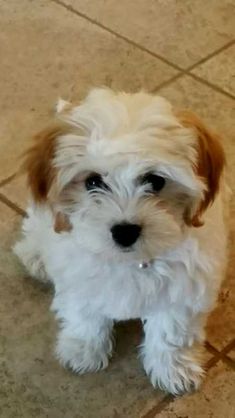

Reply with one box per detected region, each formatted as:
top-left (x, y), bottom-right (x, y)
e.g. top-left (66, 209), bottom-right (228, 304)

top-left (144, 349), bottom-right (204, 395)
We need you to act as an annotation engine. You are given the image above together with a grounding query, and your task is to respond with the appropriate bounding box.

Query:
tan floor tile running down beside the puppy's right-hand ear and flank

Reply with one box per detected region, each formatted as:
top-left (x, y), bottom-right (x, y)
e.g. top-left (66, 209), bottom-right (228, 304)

top-left (159, 77), bottom-right (235, 350)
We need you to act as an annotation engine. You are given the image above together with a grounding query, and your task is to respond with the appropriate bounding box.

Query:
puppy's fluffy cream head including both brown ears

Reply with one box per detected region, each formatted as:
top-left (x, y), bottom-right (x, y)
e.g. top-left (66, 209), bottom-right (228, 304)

top-left (26, 90), bottom-right (224, 261)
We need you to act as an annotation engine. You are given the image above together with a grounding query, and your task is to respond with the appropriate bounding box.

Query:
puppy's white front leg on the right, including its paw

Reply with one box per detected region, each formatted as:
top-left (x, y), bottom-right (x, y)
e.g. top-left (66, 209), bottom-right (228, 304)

top-left (142, 307), bottom-right (204, 394)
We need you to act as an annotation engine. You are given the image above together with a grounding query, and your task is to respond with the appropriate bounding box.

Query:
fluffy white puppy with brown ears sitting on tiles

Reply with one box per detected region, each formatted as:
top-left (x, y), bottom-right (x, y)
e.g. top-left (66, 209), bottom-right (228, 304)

top-left (15, 89), bottom-right (227, 394)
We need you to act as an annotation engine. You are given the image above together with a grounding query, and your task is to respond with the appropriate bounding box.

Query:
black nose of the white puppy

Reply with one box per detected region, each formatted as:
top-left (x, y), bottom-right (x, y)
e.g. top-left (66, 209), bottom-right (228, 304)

top-left (111, 223), bottom-right (141, 247)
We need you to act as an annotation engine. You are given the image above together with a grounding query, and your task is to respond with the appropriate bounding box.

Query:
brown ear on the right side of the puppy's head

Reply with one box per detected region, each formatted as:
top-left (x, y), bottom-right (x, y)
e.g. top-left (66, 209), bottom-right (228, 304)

top-left (177, 111), bottom-right (225, 226)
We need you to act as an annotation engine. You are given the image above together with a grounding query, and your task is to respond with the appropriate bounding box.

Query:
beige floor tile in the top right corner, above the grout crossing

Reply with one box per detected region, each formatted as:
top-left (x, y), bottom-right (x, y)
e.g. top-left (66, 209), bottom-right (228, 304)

top-left (62, 0), bottom-right (235, 68)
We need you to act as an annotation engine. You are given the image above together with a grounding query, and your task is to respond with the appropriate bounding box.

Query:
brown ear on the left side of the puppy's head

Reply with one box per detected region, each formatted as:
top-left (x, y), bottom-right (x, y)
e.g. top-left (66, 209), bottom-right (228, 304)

top-left (23, 123), bottom-right (71, 233)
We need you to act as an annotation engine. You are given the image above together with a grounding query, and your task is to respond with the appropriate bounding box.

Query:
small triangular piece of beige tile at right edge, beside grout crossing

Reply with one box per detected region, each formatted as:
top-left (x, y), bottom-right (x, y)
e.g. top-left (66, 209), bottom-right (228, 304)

top-left (193, 45), bottom-right (235, 97)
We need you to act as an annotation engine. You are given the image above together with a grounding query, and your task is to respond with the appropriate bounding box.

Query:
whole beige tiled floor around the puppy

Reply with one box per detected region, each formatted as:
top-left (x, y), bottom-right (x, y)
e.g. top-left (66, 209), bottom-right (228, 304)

top-left (0, 0), bottom-right (235, 418)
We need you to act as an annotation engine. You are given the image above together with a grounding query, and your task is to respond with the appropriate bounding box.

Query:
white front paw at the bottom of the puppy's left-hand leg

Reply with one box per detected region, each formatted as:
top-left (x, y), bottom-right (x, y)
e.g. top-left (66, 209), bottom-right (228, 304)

top-left (56, 334), bottom-right (112, 374)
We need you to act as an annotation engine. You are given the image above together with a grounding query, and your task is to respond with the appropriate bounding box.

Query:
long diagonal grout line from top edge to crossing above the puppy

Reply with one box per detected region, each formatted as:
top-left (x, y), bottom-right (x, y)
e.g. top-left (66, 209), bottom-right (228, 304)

top-left (51, 0), bottom-right (184, 71)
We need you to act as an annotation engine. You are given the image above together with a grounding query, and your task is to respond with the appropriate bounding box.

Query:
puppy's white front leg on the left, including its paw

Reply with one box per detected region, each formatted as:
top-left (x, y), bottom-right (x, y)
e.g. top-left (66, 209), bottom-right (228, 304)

top-left (56, 312), bottom-right (113, 374)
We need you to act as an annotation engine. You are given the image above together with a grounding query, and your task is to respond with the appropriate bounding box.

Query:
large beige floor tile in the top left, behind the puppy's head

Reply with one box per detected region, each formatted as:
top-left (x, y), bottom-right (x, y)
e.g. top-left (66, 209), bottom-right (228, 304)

top-left (0, 0), bottom-right (176, 180)
